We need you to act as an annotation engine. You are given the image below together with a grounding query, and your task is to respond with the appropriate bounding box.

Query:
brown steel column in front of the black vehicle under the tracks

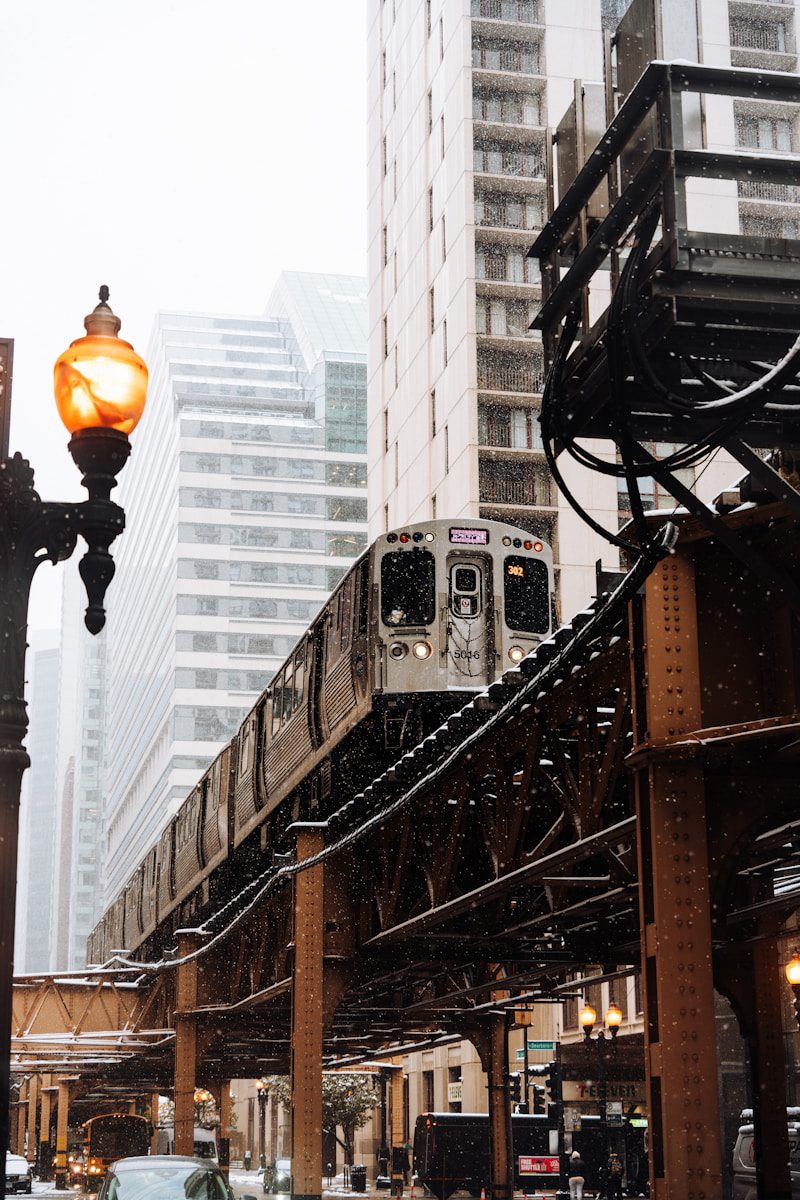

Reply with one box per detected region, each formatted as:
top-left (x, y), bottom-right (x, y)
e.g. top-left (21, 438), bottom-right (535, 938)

top-left (463, 1012), bottom-right (513, 1200)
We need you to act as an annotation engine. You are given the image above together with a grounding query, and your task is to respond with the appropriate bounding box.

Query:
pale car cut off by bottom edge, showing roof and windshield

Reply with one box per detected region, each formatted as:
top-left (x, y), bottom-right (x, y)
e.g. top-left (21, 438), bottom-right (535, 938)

top-left (98, 1154), bottom-right (257, 1200)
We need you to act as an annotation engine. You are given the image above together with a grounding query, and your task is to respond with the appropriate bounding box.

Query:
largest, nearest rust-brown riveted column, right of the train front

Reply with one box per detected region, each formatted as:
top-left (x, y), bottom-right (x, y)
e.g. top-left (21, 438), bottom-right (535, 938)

top-left (631, 547), bottom-right (722, 1200)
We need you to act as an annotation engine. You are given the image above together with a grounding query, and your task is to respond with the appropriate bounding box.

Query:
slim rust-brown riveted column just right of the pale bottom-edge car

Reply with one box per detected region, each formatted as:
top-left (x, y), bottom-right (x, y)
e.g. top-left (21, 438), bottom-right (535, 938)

top-left (290, 822), bottom-right (324, 1200)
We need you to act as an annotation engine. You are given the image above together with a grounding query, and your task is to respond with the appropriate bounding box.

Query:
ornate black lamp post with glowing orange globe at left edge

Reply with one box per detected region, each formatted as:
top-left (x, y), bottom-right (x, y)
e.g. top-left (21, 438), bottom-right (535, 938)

top-left (0, 287), bottom-right (148, 1196)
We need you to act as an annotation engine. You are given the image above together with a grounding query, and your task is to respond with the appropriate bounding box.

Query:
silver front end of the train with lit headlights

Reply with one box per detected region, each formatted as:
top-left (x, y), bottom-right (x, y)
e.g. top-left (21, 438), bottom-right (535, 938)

top-left (374, 521), bottom-right (553, 706)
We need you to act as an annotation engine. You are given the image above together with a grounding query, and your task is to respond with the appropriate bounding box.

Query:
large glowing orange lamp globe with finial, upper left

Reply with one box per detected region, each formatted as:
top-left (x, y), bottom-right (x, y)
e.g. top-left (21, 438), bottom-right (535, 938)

top-left (54, 286), bottom-right (148, 434)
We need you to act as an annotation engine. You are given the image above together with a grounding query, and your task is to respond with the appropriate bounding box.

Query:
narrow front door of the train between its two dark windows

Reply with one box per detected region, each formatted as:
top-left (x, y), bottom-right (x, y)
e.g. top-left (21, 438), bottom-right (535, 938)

top-left (447, 553), bottom-right (494, 688)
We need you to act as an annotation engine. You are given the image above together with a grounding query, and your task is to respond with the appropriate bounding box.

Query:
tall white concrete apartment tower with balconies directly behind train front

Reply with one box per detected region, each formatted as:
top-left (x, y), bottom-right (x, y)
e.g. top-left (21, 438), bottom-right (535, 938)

top-left (368, 0), bottom-right (616, 619)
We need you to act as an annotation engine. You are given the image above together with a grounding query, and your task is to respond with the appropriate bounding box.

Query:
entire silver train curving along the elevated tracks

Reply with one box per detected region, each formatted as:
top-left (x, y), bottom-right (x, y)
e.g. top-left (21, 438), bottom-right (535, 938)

top-left (88, 520), bottom-right (553, 961)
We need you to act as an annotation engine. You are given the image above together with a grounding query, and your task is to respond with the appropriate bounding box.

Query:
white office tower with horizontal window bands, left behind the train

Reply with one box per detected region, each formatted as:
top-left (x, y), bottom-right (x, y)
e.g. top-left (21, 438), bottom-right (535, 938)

top-left (99, 272), bottom-right (366, 902)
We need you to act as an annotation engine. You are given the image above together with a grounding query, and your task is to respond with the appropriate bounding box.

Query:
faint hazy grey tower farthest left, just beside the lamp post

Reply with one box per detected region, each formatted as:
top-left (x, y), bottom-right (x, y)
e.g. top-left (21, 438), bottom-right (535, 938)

top-left (14, 634), bottom-right (59, 974)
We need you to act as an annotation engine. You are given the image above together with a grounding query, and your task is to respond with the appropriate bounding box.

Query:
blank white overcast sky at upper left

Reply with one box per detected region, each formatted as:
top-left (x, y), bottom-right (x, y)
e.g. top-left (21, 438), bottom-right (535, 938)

top-left (0, 0), bottom-right (366, 629)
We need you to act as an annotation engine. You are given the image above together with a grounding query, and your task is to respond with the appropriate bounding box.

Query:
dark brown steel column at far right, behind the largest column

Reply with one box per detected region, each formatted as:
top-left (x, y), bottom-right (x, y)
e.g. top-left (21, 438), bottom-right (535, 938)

top-left (748, 941), bottom-right (792, 1200)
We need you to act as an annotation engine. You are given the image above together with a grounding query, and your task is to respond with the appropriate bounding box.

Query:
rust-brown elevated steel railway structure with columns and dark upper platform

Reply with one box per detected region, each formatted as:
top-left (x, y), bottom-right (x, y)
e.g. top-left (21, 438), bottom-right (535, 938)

top-left (12, 64), bottom-right (800, 1200)
